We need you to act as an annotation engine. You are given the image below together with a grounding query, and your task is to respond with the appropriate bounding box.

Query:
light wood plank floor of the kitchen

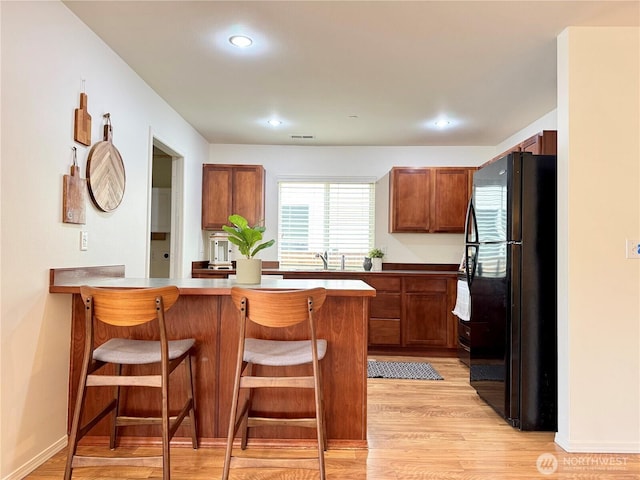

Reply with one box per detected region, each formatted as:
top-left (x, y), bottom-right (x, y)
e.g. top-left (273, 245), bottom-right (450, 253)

top-left (26, 357), bottom-right (640, 480)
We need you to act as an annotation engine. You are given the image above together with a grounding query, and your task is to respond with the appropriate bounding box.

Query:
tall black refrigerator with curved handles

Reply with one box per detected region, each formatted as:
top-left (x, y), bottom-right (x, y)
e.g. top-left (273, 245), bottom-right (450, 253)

top-left (465, 152), bottom-right (558, 431)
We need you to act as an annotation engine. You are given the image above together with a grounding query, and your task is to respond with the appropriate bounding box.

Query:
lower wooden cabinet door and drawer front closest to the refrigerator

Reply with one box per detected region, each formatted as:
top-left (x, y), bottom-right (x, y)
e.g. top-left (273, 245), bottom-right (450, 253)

top-left (403, 278), bottom-right (450, 347)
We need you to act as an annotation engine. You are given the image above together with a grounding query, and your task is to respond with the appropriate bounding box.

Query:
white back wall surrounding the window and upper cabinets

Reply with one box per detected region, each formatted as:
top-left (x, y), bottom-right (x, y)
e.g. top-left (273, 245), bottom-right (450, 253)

top-left (208, 145), bottom-right (495, 264)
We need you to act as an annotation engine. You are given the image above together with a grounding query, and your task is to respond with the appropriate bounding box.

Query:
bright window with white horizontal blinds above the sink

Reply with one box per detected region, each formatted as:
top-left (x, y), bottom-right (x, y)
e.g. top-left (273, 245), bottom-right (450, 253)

top-left (278, 179), bottom-right (375, 270)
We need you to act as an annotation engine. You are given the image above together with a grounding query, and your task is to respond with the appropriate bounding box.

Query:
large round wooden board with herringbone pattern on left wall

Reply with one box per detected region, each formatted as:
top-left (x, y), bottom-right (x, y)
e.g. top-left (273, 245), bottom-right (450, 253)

top-left (87, 114), bottom-right (126, 212)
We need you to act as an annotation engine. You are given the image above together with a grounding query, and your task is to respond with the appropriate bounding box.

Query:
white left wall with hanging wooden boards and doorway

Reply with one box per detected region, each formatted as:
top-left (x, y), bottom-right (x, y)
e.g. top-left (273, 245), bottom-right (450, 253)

top-left (0, 1), bottom-right (208, 479)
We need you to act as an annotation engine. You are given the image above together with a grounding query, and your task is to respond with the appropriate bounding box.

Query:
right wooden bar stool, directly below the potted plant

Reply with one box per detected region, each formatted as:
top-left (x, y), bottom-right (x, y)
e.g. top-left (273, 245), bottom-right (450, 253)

top-left (222, 287), bottom-right (327, 480)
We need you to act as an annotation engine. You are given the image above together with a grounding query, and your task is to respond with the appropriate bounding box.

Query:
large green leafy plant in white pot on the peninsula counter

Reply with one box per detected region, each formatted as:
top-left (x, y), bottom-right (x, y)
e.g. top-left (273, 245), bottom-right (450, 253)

top-left (222, 214), bottom-right (276, 284)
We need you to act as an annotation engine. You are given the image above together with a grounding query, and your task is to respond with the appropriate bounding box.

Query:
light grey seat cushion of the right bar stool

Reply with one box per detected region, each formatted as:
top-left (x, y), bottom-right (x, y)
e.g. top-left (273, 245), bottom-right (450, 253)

top-left (244, 338), bottom-right (327, 367)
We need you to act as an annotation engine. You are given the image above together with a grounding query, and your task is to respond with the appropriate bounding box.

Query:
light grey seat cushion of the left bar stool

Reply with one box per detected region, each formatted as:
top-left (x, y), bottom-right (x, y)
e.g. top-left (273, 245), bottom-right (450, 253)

top-left (93, 338), bottom-right (196, 365)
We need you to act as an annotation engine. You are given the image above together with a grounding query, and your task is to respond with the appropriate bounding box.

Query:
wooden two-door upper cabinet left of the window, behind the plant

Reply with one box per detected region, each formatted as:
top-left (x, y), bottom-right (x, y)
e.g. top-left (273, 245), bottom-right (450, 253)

top-left (202, 164), bottom-right (264, 230)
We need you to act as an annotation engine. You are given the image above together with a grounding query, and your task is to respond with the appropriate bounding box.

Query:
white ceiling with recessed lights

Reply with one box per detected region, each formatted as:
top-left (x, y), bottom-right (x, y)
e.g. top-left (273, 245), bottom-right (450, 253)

top-left (64, 0), bottom-right (640, 146)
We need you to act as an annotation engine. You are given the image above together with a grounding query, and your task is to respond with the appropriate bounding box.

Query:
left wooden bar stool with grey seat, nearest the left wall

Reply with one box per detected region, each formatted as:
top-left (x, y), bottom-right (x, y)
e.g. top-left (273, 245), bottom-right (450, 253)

top-left (64, 286), bottom-right (198, 480)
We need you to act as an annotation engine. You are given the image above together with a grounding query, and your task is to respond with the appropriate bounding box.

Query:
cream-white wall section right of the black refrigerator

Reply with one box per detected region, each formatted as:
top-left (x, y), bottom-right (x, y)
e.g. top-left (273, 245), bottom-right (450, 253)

top-left (556, 27), bottom-right (640, 453)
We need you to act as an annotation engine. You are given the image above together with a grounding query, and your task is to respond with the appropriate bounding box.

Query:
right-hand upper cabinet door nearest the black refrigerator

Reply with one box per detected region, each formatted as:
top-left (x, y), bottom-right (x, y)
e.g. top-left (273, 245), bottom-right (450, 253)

top-left (431, 168), bottom-right (470, 233)
